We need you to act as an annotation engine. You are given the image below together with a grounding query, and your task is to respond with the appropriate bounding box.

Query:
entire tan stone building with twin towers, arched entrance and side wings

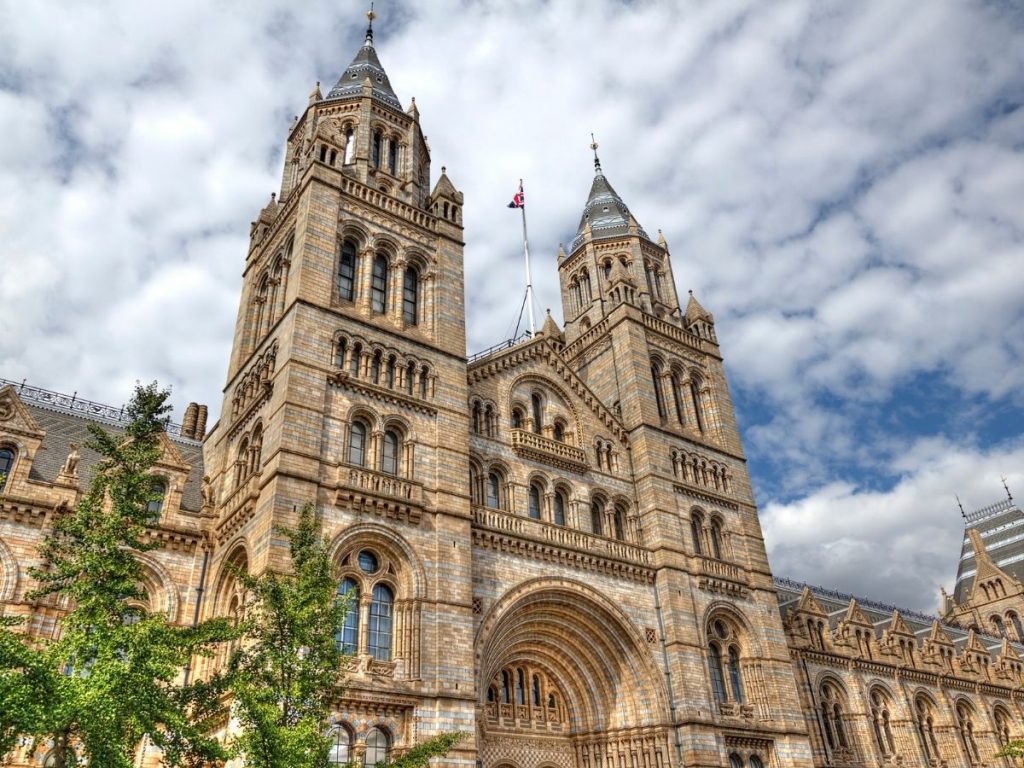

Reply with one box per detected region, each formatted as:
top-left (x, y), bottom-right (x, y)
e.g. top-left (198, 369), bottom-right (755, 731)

top-left (0, 16), bottom-right (1024, 768)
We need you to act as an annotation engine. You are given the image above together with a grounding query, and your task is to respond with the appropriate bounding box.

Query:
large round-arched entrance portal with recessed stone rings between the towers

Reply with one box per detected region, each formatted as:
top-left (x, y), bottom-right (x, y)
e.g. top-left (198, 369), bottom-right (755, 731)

top-left (476, 579), bottom-right (675, 768)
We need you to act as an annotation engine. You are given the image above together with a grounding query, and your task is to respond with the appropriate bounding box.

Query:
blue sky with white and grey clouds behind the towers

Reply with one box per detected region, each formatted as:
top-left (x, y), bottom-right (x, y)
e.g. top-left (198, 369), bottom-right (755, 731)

top-left (0, 0), bottom-right (1024, 610)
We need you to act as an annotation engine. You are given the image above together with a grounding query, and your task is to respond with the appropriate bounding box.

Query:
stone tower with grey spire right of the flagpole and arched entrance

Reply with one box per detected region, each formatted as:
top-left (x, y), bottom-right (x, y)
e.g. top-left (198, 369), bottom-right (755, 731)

top-left (558, 143), bottom-right (810, 765)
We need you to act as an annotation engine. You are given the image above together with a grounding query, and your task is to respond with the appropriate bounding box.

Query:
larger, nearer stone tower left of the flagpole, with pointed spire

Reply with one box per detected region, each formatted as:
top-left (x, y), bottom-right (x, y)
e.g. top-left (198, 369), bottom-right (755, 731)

top-left (205, 17), bottom-right (473, 765)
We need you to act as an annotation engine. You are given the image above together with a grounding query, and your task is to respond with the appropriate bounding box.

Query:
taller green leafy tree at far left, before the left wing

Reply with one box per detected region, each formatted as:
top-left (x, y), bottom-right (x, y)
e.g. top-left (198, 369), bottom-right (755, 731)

top-left (0, 383), bottom-right (233, 768)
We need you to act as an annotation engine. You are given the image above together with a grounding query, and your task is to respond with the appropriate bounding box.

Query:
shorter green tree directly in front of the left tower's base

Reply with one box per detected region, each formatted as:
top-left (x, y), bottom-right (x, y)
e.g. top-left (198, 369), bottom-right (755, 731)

top-left (229, 505), bottom-right (463, 768)
